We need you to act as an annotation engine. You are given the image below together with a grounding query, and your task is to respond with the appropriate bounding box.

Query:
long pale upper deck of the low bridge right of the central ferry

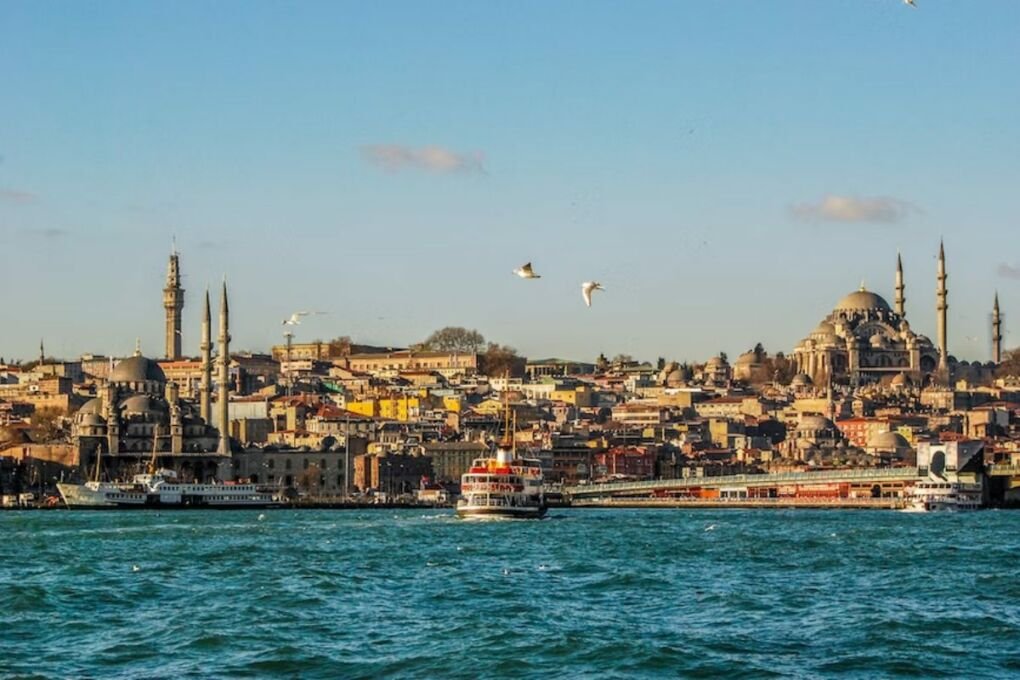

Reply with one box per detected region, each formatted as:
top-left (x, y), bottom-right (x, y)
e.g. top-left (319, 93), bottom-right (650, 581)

top-left (563, 467), bottom-right (927, 499)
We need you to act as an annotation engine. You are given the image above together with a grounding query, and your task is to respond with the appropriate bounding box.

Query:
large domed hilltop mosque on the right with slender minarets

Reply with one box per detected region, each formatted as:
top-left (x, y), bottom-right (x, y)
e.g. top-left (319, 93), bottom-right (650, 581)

top-left (793, 244), bottom-right (1002, 387)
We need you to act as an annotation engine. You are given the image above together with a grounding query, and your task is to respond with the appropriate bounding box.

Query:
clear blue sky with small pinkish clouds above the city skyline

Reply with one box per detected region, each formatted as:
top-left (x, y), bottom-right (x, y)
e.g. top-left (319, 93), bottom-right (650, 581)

top-left (0, 0), bottom-right (1020, 361)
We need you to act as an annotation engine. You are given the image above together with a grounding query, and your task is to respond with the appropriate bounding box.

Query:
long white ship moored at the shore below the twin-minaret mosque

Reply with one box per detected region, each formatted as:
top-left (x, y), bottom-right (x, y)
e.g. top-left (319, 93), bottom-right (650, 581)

top-left (57, 469), bottom-right (278, 509)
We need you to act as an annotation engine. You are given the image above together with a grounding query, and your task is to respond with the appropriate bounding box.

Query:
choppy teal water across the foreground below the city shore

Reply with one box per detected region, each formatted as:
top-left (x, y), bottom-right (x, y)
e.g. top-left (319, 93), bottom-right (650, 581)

top-left (0, 510), bottom-right (1020, 678)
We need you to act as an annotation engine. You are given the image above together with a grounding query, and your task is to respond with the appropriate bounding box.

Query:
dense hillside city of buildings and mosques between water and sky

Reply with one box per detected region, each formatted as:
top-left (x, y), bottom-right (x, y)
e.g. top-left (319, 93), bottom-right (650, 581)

top-left (0, 245), bottom-right (1020, 505)
